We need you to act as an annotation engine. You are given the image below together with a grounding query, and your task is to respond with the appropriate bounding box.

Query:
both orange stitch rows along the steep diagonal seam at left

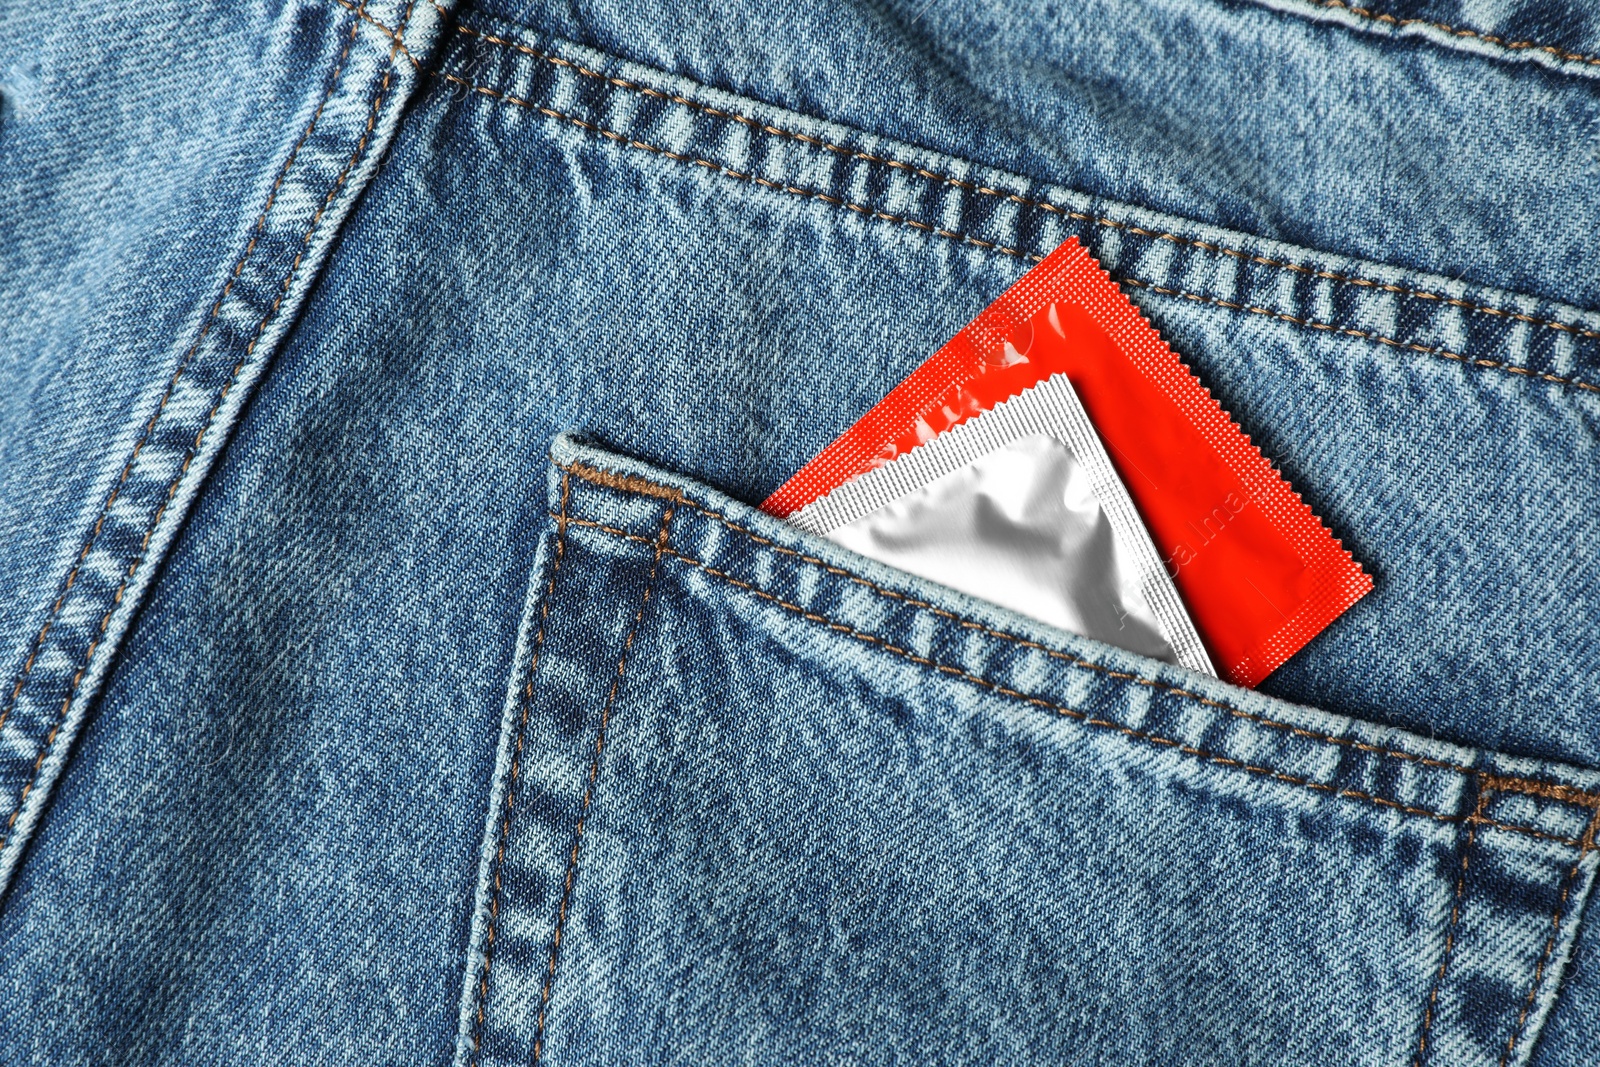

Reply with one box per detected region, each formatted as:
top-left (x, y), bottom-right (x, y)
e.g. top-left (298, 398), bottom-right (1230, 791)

top-left (0, 0), bottom-right (414, 851)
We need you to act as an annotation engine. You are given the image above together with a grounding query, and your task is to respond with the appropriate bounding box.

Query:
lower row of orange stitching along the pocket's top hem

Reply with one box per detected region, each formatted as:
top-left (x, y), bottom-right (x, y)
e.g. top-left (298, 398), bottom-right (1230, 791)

top-left (640, 549), bottom-right (1579, 846)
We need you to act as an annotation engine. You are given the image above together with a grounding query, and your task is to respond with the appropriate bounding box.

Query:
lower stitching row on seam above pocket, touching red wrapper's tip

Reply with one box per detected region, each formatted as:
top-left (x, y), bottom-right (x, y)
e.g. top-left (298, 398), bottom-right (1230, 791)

top-left (440, 68), bottom-right (1600, 394)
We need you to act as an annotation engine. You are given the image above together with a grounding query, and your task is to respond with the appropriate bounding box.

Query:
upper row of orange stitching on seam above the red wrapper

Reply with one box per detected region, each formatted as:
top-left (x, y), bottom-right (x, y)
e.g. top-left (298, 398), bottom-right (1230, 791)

top-left (446, 26), bottom-right (1600, 347)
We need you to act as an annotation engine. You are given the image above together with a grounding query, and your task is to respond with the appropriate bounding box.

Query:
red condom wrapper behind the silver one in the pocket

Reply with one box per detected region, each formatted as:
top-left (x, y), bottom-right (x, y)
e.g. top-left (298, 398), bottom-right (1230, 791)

top-left (762, 238), bottom-right (1373, 686)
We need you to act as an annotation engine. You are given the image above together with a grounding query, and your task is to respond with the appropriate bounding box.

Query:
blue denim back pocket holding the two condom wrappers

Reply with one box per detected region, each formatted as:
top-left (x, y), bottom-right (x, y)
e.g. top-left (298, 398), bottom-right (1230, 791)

top-left (459, 438), bottom-right (1600, 1067)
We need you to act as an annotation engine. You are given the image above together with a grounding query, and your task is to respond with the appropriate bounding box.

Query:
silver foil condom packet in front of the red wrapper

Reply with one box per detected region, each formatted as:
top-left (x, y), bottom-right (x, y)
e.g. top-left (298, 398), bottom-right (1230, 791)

top-left (789, 374), bottom-right (1216, 675)
